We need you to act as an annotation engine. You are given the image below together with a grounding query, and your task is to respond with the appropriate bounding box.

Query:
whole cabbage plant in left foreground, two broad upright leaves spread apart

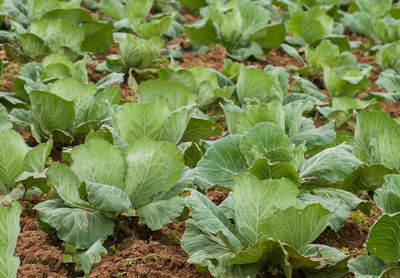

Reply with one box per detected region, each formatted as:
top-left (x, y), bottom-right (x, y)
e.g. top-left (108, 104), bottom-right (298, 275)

top-left (35, 137), bottom-right (190, 249)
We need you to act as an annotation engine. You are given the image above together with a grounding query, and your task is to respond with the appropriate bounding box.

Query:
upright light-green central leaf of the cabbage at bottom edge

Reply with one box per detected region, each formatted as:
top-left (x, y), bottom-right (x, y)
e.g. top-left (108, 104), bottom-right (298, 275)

top-left (232, 174), bottom-right (299, 246)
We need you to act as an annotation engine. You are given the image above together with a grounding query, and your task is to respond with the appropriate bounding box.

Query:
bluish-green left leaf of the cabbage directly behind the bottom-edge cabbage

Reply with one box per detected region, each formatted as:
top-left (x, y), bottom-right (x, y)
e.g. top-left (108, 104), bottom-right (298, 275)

top-left (195, 135), bottom-right (247, 188)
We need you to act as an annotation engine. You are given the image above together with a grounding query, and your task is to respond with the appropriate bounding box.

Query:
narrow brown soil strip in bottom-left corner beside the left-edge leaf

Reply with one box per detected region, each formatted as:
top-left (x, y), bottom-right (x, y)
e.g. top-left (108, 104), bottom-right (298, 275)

top-left (15, 195), bottom-right (67, 278)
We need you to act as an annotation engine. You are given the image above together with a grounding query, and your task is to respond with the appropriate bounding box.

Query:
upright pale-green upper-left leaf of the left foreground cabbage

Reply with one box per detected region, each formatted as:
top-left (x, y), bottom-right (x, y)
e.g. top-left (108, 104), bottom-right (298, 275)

top-left (71, 138), bottom-right (125, 189)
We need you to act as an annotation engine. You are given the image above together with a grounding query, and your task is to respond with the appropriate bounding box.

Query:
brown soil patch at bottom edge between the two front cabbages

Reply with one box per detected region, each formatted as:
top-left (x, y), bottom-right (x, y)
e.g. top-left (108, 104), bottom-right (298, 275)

top-left (89, 221), bottom-right (211, 278)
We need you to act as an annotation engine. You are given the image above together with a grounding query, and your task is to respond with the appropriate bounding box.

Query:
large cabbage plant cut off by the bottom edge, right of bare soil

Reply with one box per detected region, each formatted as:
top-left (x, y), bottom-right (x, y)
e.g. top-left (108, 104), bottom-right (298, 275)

top-left (182, 173), bottom-right (349, 277)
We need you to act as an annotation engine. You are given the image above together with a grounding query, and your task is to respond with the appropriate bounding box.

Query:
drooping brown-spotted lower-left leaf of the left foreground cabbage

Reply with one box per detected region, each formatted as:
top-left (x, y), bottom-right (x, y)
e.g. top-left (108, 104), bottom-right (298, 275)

top-left (35, 200), bottom-right (114, 249)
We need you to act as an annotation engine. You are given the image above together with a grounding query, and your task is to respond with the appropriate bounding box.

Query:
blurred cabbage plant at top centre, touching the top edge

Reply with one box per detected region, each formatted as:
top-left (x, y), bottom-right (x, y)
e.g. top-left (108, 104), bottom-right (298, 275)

top-left (185, 0), bottom-right (285, 61)
